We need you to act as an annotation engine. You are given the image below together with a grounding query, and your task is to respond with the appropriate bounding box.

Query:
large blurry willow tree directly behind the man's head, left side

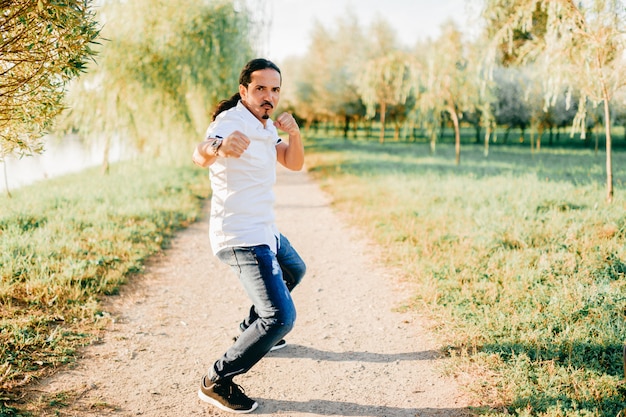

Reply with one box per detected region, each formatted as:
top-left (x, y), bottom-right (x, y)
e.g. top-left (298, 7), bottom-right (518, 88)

top-left (56, 0), bottom-right (252, 170)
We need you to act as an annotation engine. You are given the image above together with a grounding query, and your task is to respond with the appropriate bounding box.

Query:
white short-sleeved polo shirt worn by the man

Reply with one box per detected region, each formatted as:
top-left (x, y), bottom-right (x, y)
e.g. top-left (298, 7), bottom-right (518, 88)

top-left (206, 101), bottom-right (281, 254)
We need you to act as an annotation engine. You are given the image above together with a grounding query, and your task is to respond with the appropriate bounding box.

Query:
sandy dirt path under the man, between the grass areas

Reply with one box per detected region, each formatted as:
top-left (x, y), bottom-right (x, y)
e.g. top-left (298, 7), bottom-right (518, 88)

top-left (33, 167), bottom-right (470, 417)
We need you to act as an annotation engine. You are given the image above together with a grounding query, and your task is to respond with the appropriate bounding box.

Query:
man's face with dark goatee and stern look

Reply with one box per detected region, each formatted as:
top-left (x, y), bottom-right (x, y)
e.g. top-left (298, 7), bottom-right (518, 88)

top-left (239, 68), bottom-right (280, 125)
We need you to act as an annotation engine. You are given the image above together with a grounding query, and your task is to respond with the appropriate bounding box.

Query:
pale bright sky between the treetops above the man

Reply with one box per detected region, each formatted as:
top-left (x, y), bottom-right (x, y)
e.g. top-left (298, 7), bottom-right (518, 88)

top-left (265, 0), bottom-right (479, 62)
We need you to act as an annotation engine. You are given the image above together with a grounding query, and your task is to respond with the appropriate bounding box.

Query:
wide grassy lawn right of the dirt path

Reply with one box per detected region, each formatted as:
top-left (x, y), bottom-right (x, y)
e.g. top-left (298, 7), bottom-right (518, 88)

top-left (307, 139), bottom-right (626, 417)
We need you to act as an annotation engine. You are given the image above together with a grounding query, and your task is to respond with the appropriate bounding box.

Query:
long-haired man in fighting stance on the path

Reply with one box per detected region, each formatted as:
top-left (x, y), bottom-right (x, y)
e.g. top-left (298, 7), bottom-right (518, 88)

top-left (193, 59), bottom-right (306, 413)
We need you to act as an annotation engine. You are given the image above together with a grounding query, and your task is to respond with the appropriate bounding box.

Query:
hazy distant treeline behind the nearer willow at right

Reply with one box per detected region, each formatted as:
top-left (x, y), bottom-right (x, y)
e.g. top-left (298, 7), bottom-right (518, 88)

top-left (276, 2), bottom-right (626, 154)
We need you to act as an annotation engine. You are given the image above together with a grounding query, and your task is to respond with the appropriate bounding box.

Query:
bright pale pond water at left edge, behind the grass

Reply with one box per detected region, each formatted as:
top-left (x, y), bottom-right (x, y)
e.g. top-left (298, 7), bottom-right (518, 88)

top-left (0, 136), bottom-right (128, 192)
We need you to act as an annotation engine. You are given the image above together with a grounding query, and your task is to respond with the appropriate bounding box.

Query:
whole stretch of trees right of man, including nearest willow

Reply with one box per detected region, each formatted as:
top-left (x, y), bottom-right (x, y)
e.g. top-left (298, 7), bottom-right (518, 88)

top-left (284, 0), bottom-right (626, 201)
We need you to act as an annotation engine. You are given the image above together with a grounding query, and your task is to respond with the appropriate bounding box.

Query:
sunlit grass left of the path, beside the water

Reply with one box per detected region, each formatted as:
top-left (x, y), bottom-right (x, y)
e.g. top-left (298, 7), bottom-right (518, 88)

top-left (0, 160), bottom-right (210, 416)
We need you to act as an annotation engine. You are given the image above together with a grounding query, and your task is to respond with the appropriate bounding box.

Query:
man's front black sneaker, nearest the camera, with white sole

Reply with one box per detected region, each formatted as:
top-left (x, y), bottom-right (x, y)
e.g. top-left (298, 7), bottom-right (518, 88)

top-left (198, 375), bottom-right (259, 414)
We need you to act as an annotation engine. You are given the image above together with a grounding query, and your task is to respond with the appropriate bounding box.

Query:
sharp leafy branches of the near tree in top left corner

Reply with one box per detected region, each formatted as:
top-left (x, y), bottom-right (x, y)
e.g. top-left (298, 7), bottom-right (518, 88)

top-left (0, 0), bottom-right (99, 161)
